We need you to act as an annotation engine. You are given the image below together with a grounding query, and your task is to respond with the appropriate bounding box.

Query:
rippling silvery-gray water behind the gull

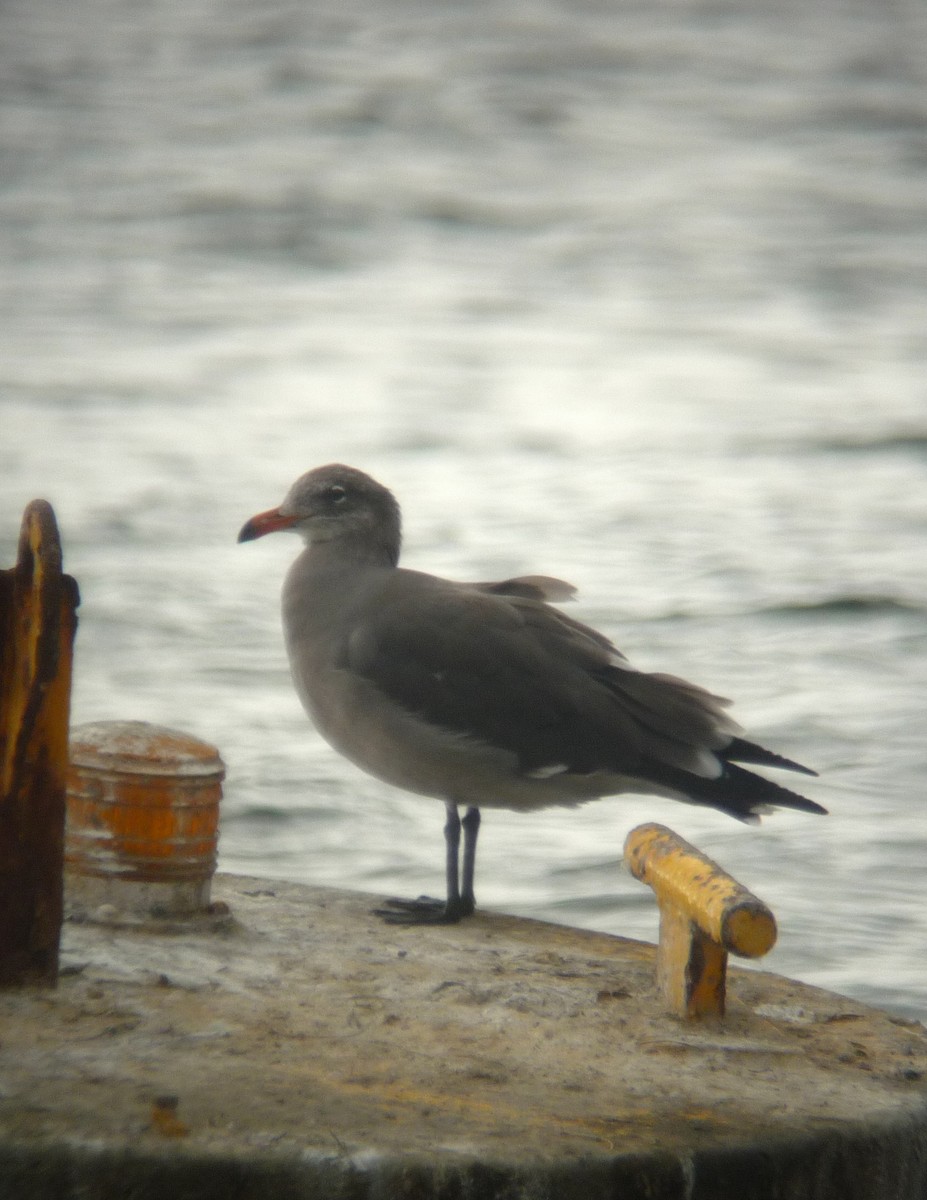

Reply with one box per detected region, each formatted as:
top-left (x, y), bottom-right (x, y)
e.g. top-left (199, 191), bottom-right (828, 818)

top-left (0, 0), bottom-right (927, 1016)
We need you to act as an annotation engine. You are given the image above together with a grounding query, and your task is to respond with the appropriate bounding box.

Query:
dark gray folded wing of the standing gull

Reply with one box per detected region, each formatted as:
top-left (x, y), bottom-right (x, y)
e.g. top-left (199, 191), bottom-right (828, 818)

top-left (345, 572), bottom-right (736, 775)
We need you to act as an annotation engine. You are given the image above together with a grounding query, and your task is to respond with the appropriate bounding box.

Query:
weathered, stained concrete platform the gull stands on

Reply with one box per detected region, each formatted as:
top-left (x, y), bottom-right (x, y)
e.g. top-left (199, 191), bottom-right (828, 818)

top-left (0, 876), bottom-right (927, 1200)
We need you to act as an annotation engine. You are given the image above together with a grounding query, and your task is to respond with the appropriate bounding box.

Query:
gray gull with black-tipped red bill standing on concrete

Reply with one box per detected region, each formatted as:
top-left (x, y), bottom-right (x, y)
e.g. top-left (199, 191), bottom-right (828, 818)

top-left (238, 463), bottom-right (826, 924)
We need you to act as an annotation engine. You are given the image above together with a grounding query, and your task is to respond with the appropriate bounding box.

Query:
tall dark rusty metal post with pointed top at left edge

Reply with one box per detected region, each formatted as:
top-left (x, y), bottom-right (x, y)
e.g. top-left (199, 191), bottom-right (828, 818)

top-left (0, 500), bottom-right (79, 988)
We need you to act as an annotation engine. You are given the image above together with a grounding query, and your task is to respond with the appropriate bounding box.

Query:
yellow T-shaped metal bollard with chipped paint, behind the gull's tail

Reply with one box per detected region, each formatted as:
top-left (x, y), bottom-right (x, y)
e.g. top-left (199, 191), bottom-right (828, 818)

top-left (624, 824), bottom-right (776, 1018)
